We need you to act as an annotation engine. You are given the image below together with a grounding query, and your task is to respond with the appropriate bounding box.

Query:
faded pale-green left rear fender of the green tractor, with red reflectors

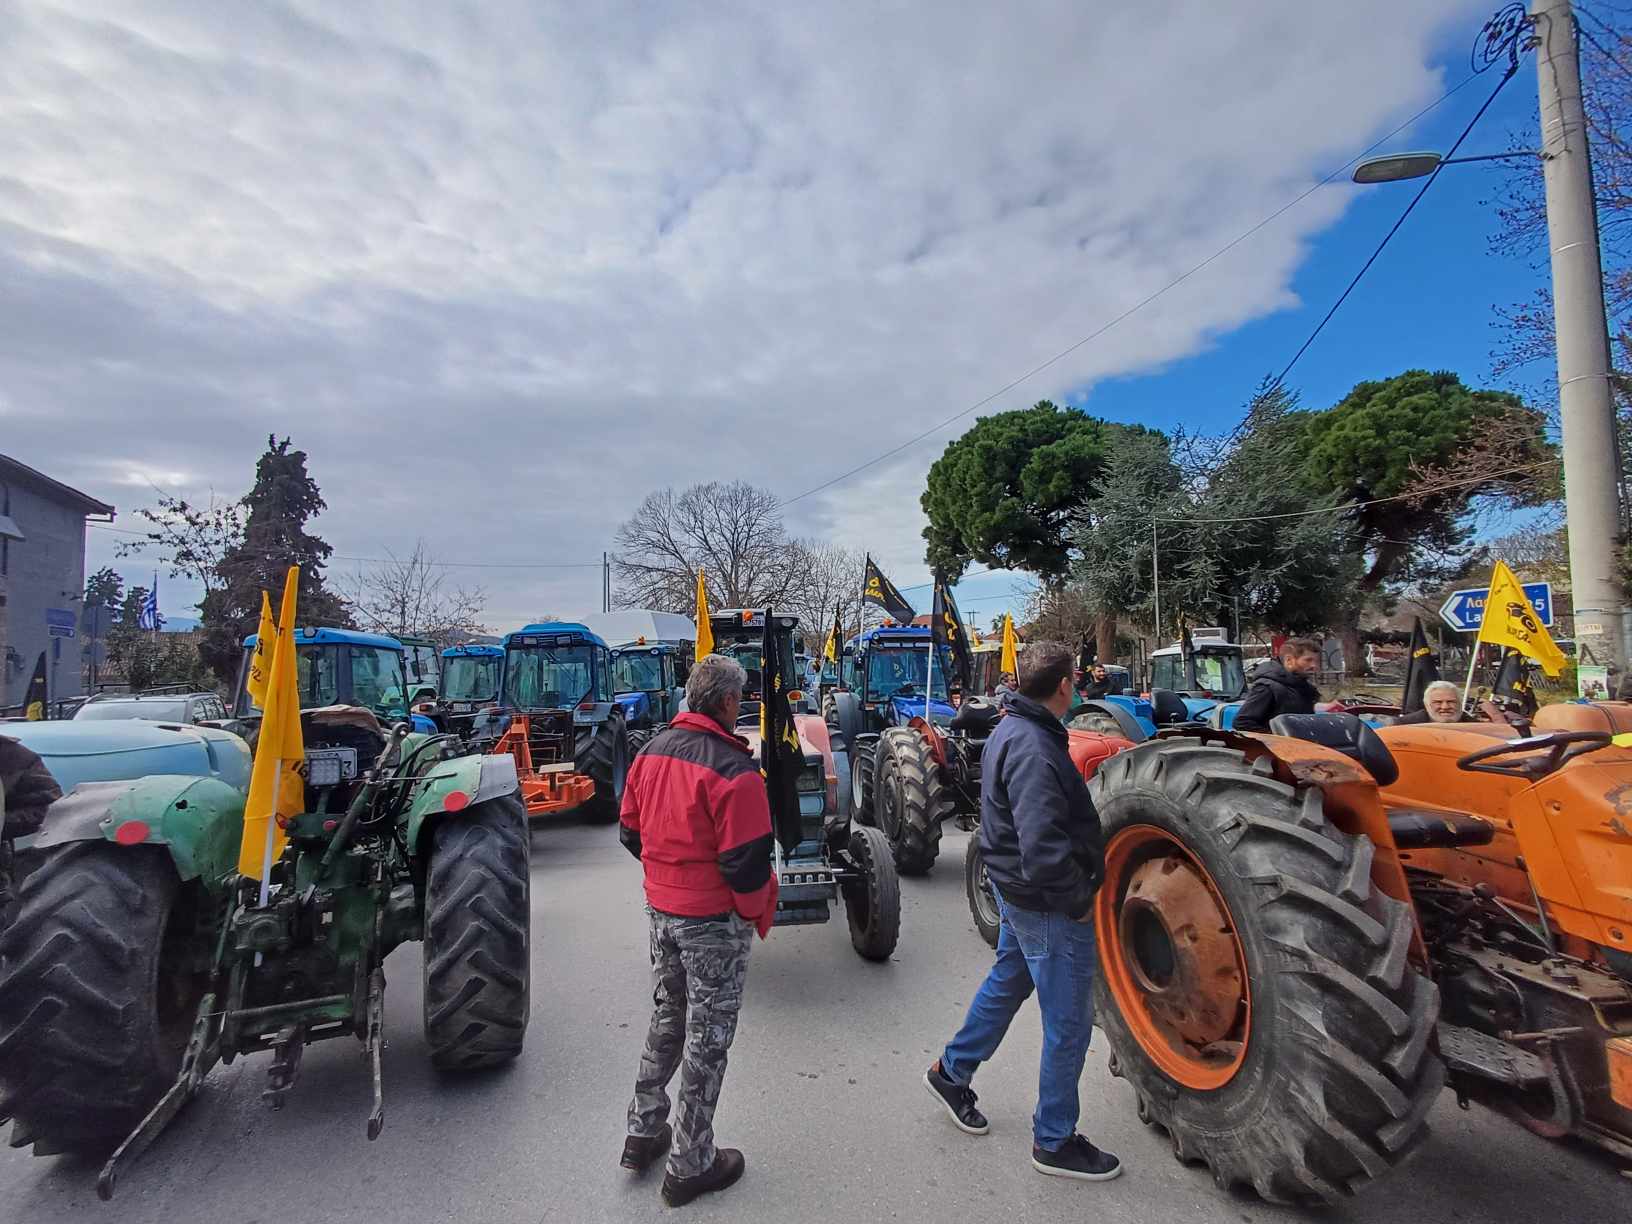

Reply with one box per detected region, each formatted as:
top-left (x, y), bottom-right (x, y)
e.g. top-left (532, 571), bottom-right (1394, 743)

top-left (33, 774), bottom-right (245, 881)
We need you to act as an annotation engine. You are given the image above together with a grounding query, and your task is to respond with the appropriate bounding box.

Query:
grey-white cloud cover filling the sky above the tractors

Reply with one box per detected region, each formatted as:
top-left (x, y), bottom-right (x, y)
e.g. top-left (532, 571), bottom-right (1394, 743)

top-left (0, 0), bottom-right (1507, 628)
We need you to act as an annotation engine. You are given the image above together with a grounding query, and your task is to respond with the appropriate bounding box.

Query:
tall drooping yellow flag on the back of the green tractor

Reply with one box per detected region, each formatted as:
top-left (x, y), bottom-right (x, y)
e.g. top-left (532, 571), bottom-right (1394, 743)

top-left (238, 565), bottom-right (305, 880)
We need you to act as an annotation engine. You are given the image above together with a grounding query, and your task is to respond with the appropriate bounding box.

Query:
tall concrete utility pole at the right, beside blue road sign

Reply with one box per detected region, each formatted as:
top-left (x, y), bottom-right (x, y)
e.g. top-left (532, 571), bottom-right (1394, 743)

top-left (1531, 0), bottom-right (1627, 667)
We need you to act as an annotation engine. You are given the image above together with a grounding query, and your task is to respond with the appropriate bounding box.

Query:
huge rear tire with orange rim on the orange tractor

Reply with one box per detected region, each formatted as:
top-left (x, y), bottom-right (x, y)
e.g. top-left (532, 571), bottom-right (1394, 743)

top-left (1090, 741), bottom-right (1444, 1203)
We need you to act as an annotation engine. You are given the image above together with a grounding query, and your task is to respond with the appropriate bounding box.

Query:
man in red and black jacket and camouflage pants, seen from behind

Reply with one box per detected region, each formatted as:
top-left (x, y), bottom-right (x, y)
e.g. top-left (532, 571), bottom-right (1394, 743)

top-left (619, 654), bottom-right (777, 1206)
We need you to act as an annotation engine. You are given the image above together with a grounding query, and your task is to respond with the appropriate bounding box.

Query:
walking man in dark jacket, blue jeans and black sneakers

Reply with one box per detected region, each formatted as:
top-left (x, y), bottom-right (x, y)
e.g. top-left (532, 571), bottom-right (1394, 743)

top-left (924, 641), bottom-right (1121, 1182)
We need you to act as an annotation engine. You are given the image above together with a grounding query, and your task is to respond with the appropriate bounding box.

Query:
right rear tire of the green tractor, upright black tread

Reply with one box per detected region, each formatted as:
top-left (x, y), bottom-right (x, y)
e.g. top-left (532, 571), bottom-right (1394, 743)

top-left (424, 795), bottom-right (530, 1071)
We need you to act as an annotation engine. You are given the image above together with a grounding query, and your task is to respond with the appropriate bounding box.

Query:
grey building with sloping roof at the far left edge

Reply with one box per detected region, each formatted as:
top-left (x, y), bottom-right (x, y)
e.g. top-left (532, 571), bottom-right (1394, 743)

top-left (0, 455), bottom-right (113, 708)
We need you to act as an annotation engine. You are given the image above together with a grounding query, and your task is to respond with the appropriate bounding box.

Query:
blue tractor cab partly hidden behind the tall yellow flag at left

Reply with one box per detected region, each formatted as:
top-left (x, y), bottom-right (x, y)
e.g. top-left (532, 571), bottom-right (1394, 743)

top-left (232, 627), bottom-right (436, 731)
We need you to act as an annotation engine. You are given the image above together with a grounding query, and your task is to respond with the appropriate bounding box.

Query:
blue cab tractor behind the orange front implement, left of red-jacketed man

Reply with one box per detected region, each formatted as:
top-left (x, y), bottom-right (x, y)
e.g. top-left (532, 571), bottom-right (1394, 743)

top-left (492, 620), bottom-right (630, 821)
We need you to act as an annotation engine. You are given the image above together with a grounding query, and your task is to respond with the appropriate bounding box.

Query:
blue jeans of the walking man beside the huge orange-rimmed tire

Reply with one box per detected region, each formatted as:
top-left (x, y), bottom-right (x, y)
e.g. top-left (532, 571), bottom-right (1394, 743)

top-left (940, 889), bottom-right (1097, 1152)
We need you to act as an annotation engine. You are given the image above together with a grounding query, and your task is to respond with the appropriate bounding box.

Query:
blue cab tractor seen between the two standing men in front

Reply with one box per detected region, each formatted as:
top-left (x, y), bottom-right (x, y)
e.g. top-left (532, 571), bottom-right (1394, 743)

top-left (823, 623), bottom-right (999, 875)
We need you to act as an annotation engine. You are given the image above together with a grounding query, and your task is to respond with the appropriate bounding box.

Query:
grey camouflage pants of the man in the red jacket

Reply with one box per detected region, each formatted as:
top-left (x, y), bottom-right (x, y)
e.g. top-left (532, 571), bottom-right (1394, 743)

top-left (628, 906), bottom-right (754, 1177)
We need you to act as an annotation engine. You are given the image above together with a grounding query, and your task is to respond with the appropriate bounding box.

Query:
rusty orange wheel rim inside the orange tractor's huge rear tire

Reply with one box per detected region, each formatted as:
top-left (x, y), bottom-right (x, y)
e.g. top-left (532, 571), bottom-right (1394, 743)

top-left (1093, 824), bottom-right (1252, 1090)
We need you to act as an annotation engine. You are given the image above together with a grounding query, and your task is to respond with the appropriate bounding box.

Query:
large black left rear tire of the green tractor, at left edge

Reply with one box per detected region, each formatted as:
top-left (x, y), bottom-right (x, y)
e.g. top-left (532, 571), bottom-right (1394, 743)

top-left (0, 840), bottom-right (204, 1155)
